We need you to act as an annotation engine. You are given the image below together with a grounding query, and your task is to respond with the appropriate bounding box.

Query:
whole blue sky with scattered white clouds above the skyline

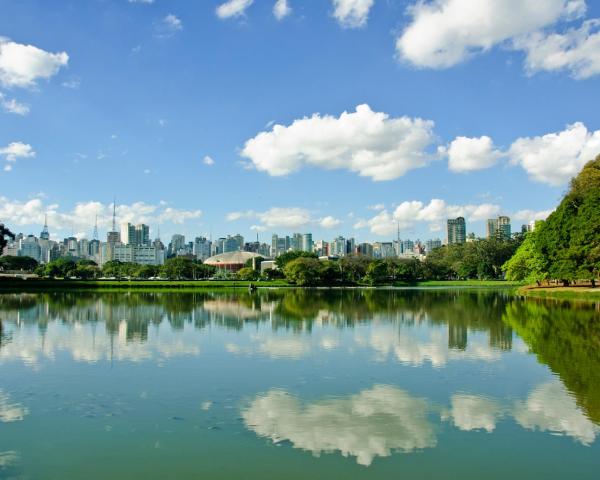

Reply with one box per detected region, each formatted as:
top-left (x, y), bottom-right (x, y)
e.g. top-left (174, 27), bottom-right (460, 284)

top-left (0, 0), bottom-right (600, 241)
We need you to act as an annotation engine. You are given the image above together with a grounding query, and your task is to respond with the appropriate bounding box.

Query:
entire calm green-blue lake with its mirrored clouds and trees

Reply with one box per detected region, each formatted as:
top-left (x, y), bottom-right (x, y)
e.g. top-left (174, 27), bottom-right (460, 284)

top-left (0, 290), bottom-right (600, 480)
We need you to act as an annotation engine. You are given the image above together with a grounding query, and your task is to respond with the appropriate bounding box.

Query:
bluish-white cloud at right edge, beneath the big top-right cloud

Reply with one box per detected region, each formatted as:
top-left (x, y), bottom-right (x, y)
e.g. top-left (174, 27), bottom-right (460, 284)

top-left (514, 19), bottom-right (600, 79)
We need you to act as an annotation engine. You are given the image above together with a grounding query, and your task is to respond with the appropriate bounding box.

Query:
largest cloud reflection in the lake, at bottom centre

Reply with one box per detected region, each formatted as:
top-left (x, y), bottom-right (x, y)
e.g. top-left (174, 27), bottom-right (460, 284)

top-left (242, 385), bottom-right (437, 466)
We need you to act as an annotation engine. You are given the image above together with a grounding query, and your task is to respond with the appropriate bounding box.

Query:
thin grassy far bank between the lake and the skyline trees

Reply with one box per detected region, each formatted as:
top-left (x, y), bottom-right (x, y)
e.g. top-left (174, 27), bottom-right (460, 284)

top-left (0, 278), bottom-right (521, 292)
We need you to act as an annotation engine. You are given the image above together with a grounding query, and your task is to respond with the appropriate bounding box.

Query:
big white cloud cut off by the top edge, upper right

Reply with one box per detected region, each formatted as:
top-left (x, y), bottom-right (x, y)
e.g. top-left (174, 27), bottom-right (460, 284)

top-left (396, 0), bottom-right (586, 68)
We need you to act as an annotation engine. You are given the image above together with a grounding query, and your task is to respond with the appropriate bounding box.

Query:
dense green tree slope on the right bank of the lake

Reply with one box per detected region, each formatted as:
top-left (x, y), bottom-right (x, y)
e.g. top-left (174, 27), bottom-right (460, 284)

top-left (503, 156), bottom-right (600, 285)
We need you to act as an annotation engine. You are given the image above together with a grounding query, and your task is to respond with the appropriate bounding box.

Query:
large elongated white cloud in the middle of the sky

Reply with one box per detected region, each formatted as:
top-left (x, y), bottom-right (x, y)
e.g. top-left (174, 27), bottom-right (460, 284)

top-left (242, 105), bottom-right (434, 180)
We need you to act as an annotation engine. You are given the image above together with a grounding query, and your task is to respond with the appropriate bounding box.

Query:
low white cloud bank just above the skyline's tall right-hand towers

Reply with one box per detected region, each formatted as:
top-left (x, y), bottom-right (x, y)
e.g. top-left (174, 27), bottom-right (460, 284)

top-left (354, 198), bottom-right (501, 235)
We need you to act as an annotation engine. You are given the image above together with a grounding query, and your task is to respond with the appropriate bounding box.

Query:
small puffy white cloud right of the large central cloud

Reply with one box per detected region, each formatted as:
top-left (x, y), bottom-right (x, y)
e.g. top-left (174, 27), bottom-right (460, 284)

top-left (440, 136), bottom-right (503, 172)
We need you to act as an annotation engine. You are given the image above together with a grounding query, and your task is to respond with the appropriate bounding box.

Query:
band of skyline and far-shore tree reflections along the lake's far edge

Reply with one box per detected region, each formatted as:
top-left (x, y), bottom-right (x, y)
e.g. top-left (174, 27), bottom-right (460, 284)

top-left (0, 289), bottom-right (512, 350)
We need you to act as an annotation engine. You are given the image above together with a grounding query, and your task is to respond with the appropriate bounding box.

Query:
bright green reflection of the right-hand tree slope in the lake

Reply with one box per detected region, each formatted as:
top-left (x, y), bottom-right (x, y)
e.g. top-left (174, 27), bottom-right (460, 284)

top-left (503, 299), bottom-right (600, 423)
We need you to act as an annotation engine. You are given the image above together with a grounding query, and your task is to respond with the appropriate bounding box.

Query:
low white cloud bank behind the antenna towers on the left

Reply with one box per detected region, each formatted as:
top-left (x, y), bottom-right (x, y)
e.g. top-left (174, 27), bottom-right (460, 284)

top-left (0, 196), bottom-right (202, 231)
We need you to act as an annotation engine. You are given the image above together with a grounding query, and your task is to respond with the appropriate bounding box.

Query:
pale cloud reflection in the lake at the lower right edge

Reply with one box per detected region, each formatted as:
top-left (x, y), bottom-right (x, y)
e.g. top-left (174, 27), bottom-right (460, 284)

top-left (513, 381), bottom-right (598, 445)
